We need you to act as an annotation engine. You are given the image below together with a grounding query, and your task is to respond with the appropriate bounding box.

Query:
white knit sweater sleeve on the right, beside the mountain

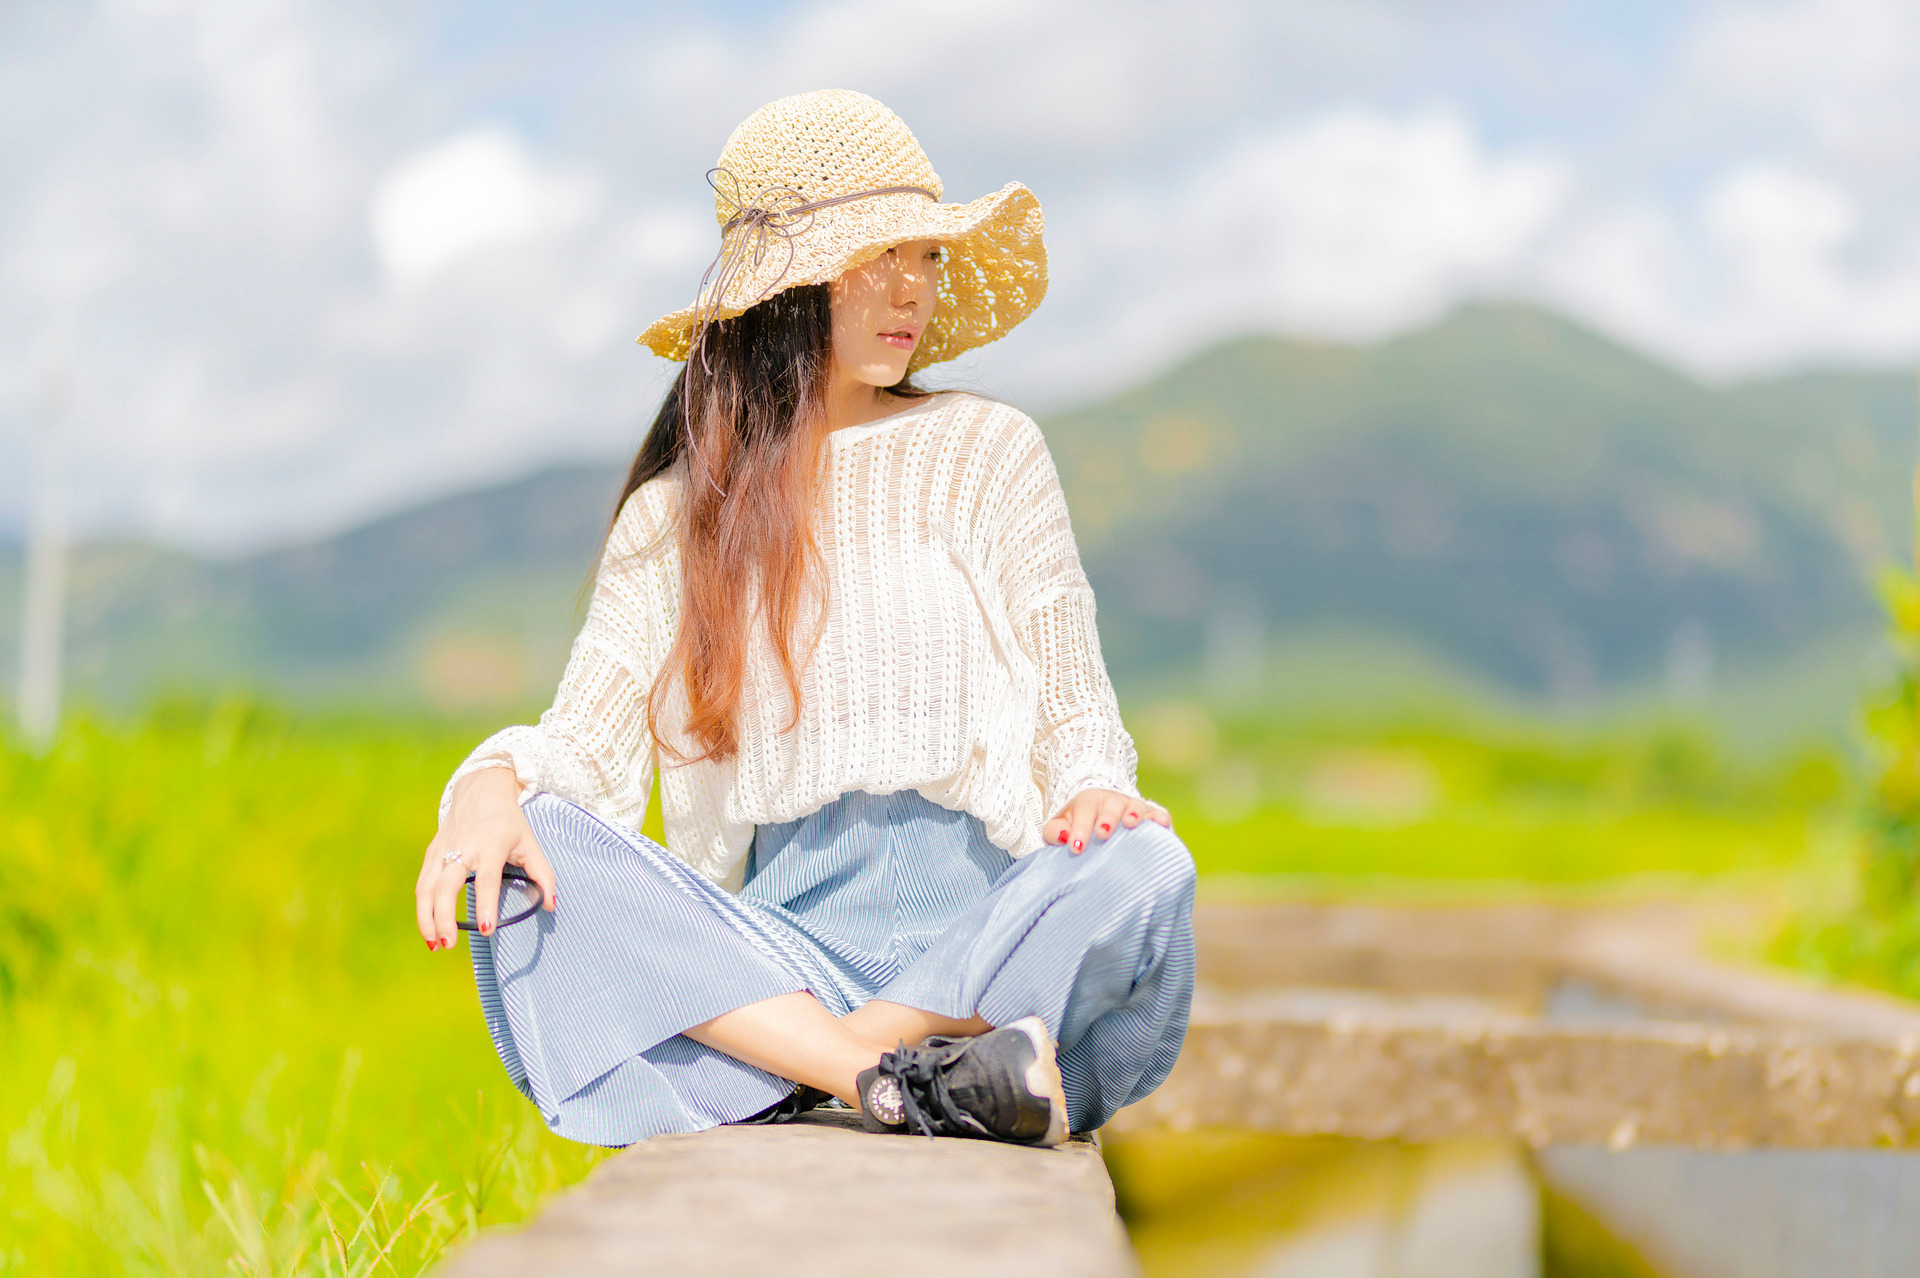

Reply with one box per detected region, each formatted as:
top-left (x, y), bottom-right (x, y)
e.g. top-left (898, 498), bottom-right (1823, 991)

top-left (991, 416), bottom-right (1139, 817)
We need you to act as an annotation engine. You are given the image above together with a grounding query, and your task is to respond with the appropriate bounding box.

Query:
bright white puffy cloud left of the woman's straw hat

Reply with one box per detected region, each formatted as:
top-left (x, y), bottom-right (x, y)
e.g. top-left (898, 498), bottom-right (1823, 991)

top-left (367, 129), bottom-right (601, 284)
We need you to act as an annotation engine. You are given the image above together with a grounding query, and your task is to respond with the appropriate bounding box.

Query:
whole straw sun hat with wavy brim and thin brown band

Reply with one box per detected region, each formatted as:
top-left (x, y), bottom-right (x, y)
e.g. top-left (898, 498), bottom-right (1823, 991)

top-left (639, 88), bottom-right (1046, 372)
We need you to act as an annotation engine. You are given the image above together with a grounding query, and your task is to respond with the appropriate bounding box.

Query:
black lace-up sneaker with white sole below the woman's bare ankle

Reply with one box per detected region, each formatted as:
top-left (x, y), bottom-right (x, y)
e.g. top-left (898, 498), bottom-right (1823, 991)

top-left (858, 1017), bottom-right (1068, 1146)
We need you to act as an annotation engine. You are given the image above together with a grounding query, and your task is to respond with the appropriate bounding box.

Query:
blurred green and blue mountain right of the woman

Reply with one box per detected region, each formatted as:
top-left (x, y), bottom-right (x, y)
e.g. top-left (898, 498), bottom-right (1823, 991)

top-left (1046, 305), bottom-right (1916, 698)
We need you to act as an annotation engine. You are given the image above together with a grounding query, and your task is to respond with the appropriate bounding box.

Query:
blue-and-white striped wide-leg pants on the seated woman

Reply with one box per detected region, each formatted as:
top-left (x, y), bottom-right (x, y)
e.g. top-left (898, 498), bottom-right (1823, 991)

top-left (468, 791), bottom-right (1194, 1146)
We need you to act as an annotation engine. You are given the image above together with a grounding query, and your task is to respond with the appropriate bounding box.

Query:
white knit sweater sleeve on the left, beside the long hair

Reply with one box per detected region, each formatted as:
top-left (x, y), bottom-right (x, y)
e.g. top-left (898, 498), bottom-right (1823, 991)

top-left (440, 489), bottom-right (678, 829)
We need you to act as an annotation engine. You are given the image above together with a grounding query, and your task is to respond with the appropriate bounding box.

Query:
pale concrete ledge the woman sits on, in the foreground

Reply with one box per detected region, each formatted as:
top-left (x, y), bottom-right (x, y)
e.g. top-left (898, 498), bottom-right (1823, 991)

top-left (438, 1111), bottom-right (1135, 1278)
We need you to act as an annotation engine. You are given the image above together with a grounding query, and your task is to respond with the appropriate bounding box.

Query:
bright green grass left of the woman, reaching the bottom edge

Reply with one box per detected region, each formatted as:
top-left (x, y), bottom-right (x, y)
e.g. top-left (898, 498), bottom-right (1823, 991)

top-left (0, 702), bottom-right (597, 1276)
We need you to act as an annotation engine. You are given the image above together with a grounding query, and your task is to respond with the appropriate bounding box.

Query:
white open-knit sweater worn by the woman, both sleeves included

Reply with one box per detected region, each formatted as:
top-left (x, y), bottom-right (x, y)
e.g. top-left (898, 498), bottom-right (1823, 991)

top-left (440, 393), bottom-right (1137, 887)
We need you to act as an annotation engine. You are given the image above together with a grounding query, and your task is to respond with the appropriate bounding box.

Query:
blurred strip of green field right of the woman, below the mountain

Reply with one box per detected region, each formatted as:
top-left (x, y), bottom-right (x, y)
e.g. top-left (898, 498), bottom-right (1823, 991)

top-left (1135, 702), bottom-right (1847, 894)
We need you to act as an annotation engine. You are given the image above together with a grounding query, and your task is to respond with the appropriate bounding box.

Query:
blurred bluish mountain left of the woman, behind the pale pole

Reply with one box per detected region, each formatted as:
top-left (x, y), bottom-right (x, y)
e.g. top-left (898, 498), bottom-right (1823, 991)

top-left (0, 466), bottom-right (620, 710)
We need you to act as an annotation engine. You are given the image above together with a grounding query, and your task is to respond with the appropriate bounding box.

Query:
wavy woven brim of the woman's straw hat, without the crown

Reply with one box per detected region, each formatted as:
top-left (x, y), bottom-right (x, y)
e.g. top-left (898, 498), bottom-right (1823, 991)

top-left (639, 182), bottom-right (1046, 372)
